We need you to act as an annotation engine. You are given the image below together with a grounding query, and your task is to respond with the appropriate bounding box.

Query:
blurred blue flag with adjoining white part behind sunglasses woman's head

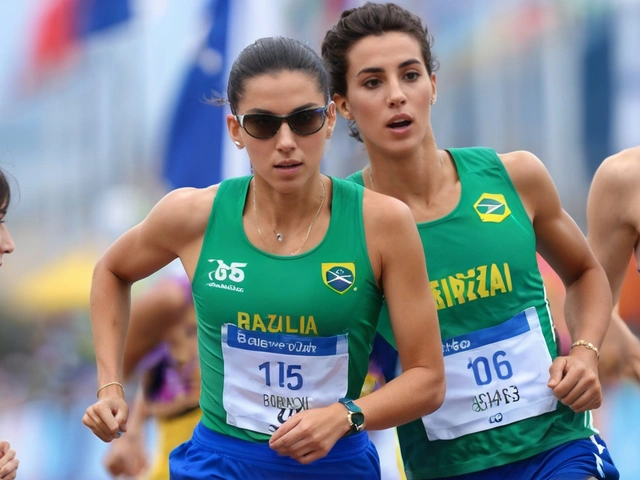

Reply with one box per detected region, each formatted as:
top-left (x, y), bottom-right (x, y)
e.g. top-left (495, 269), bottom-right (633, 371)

top-left (163, 0), bottom-right (289, 188)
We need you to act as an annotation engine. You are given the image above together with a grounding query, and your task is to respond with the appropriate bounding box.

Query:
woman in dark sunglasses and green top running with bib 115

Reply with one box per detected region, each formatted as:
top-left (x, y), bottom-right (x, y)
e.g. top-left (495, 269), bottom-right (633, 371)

top-left (83, 38), bottom-right (444, 480)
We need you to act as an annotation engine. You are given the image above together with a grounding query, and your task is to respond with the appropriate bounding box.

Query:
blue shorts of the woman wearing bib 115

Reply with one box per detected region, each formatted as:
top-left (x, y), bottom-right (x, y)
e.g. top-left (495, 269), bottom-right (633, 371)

top-left (169, 423), bottom-right (380, 480)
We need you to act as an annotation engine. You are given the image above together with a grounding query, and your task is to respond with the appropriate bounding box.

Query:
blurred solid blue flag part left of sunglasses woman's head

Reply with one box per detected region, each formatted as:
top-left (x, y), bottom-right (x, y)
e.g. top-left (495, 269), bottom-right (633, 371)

top-left (163, 0), bottom-right (229, 188)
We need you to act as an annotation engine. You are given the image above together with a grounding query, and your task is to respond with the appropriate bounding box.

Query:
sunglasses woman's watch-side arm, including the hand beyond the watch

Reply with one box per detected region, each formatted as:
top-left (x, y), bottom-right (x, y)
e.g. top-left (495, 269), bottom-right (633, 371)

top-left (270, 190), bottom-right (445, 464)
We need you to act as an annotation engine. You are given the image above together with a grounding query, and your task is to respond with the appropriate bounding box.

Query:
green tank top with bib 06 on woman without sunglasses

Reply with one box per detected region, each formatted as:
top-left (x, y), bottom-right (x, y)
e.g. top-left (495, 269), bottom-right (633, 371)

top-left (349, 148), bottom-right (597, 479)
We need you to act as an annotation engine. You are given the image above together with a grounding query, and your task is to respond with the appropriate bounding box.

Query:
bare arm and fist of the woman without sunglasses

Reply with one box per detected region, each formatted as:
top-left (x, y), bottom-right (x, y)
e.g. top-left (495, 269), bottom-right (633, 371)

top-left (501, 151), bottom-right (611, 412)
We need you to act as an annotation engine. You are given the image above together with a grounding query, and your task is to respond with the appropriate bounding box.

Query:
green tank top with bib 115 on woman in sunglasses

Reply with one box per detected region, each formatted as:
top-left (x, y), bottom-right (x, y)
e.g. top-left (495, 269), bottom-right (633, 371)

top-left (192, 177), bottom-right (382, 441)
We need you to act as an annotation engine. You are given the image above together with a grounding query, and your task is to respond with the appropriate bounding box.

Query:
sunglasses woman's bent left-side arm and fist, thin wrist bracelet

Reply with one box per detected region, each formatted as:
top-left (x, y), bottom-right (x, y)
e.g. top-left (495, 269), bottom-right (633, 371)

top-left (83, 187), bottom-right (212, 441)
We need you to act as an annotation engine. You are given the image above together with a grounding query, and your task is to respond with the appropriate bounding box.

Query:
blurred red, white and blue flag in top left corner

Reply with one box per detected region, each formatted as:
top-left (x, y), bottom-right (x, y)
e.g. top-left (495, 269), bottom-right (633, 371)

top-left (24, 0), bottom-right (133, 88)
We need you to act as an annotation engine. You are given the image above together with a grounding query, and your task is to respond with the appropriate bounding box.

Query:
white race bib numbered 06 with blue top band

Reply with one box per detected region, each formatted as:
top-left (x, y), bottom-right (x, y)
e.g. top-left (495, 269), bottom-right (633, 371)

top-left (422, 307), bottom-right (557, 440)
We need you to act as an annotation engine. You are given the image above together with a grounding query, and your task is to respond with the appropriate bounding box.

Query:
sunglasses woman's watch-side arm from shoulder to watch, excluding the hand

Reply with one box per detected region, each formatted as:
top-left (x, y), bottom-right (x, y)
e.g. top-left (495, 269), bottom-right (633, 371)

top-left (356, 190), bottom-right (445, 430)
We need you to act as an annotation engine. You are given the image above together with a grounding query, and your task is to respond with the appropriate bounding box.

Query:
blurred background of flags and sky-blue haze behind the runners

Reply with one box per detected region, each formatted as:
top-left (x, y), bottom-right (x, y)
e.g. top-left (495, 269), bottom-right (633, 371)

top-left (0, 0), bottom-right (640, 480)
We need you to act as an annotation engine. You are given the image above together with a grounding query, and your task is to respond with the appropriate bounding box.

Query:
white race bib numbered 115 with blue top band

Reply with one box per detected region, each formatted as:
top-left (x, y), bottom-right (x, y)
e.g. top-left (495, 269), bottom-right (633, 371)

top-left (222, 324), bottom-right (349, 435)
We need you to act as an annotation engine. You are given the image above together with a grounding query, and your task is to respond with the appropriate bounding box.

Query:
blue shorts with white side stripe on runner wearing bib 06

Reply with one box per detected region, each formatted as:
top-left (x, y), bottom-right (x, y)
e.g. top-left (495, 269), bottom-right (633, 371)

top-left (432, 435), bottom-right (620, 480)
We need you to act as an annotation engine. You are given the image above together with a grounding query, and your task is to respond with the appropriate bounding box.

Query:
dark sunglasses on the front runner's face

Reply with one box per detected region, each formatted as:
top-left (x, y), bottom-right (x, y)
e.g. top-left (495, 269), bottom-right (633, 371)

top-left (235, 103), bottom-right (331, 140)
